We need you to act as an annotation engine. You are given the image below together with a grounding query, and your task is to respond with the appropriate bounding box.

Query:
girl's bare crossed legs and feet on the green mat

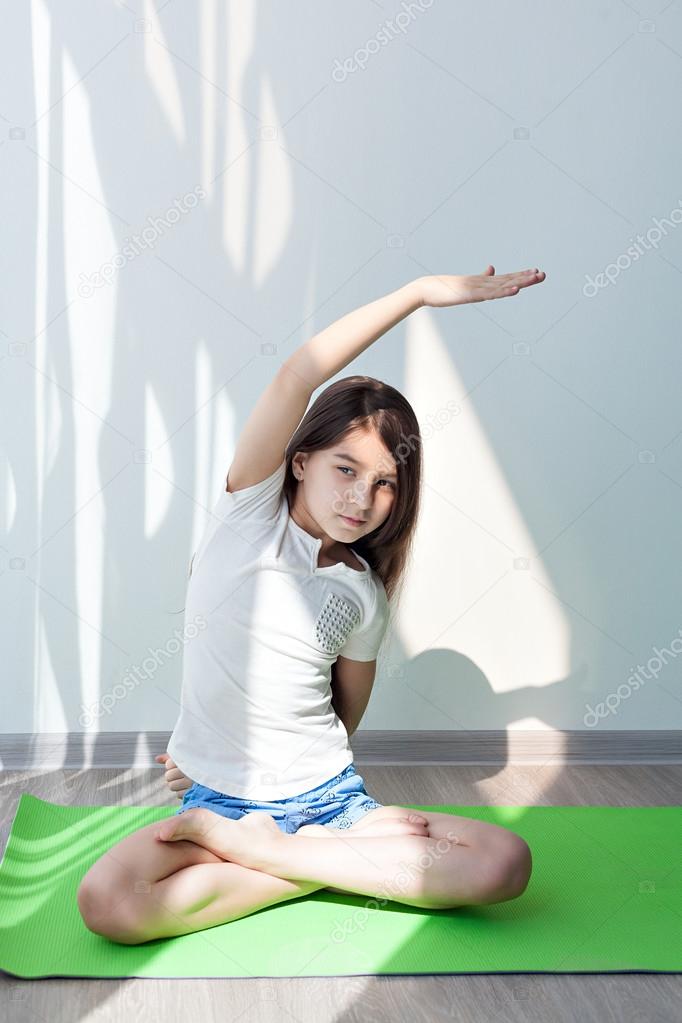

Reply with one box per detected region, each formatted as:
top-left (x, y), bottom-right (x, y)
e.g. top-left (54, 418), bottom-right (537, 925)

top-left (78, 806), bottom-right (531, 944)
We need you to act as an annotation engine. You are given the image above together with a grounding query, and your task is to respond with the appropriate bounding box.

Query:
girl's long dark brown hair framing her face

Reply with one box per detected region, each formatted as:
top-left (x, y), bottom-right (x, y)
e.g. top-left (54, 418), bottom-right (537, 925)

top-left (282, 375), bottom-right (422, 601)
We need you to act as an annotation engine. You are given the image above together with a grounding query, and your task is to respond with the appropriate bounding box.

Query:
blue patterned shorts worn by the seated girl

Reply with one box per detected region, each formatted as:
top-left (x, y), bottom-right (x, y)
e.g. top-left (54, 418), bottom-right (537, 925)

top-left (175, 764), bottom-right (382, 835)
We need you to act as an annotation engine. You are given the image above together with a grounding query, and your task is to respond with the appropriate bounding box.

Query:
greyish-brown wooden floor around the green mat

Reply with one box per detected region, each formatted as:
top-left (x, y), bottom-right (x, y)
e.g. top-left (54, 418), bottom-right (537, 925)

top-left (0, 762), bottom-right (682, 1023)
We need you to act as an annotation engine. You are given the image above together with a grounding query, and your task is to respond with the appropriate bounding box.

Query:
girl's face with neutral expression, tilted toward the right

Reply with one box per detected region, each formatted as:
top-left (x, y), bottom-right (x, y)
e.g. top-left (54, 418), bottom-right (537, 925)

top-left (292, 431), bottom-right (398, 544)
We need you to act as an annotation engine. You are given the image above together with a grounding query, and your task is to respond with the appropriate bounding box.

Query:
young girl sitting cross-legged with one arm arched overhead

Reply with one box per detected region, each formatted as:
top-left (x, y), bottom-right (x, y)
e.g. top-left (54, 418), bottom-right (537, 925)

top-left (78, 266), bottom-right (545, 944)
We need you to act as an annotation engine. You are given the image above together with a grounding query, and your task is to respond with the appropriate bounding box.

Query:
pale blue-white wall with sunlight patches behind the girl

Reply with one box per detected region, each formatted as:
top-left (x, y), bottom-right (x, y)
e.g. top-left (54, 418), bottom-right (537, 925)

top-left (0, 0), bottom-right (682, 748)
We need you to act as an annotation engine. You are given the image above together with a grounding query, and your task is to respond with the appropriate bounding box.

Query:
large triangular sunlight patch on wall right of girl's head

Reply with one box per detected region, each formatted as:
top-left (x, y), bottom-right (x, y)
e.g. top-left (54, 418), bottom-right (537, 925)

top-left (400, 309), bottom-right (571, 695)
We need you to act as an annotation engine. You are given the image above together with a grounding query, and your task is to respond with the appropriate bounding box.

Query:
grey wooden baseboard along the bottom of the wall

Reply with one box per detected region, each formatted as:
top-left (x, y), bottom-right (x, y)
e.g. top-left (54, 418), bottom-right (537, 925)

top-left (0, 728), bottom-right (682, 770)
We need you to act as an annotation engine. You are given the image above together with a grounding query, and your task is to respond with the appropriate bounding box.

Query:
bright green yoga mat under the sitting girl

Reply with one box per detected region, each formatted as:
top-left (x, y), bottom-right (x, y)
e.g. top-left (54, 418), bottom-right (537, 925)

top-left (0, 794), bottom-right (682, 978)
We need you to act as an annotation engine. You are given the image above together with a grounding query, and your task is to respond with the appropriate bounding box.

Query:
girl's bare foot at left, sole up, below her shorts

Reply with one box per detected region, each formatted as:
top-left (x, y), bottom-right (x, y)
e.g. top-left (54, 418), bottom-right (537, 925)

top-left (154, 806), bottom-right (282, 869)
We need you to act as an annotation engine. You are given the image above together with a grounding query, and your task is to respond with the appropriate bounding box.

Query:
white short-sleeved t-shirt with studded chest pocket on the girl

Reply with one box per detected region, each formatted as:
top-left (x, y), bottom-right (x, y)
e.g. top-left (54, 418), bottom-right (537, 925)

top-left (168, 461), bottom-right (389, 801)
